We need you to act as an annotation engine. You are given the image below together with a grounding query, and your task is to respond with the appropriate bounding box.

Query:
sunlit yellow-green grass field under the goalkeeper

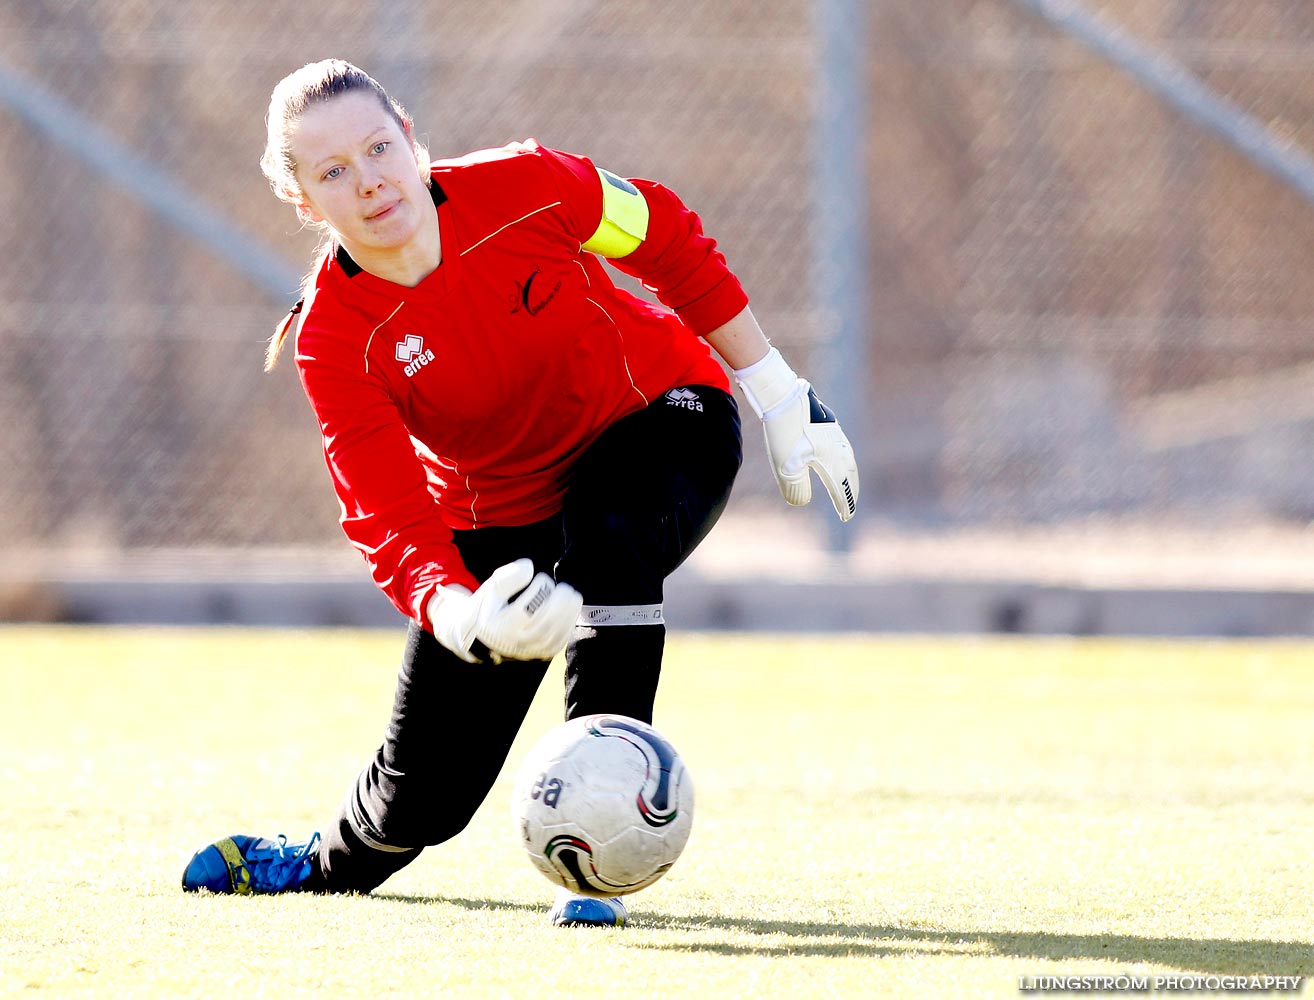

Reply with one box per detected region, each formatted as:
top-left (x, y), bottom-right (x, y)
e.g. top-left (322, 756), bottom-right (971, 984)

top-left (0, 627), bottom-right (1314, 999)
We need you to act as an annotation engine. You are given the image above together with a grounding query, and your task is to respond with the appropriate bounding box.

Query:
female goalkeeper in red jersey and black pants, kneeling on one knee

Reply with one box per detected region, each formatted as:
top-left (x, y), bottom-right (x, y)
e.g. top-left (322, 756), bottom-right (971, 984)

top-left (183, 59), bottom-right (858, 924)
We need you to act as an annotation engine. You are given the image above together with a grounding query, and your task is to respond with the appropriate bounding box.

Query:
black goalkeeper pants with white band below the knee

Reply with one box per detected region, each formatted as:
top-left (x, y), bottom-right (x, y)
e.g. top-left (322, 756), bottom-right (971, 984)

top-left (305, 385), bottom-right (742, 892)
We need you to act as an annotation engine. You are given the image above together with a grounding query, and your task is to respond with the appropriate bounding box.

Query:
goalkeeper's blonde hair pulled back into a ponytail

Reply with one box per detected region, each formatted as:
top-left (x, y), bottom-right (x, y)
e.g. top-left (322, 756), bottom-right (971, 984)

top-left (260, 59), bottom-right (428, 372)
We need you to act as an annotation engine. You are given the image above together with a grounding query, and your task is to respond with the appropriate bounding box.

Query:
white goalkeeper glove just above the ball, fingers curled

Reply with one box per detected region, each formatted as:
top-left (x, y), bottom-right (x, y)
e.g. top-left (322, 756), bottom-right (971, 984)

top-left (426, 558), bottom-right (583, 664)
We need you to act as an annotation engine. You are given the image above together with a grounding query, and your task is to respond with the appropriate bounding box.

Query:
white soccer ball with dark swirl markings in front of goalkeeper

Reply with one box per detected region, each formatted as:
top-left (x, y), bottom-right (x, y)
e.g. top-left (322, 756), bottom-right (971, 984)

top-left (511, 715), bottom-right (694, 896)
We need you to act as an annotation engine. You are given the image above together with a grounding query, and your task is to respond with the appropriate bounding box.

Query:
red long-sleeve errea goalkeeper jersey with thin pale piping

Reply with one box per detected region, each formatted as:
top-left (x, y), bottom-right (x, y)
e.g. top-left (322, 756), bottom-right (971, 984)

top-left (297, 141), bottom-right (748, 625)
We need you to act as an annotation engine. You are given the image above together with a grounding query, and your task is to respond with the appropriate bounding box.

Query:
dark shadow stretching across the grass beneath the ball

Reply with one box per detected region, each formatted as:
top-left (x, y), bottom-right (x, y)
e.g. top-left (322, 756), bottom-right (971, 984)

top-left (373, 894), bottom-right (1314, 975)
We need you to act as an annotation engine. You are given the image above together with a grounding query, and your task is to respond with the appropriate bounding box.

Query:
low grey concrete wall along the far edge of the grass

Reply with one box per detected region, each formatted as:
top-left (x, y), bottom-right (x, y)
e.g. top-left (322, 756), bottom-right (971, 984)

top-left (17, 570), bottom-right (1314, 636)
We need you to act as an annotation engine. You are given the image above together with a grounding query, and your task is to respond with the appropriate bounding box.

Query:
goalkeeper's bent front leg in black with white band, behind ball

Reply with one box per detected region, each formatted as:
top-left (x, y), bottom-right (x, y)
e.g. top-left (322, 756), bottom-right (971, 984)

top-left (557, 385), bottom-right (742, 721)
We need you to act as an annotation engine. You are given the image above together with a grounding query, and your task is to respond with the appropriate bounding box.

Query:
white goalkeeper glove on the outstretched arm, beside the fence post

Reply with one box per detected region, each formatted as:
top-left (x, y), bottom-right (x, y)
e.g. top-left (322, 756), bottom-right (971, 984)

top-left (735, 347), bottom-right (858, 520)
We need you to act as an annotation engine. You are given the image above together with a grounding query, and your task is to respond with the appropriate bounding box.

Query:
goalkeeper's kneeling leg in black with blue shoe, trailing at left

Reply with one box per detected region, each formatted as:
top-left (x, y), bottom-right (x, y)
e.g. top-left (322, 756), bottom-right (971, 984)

top-left (183, 519), bottom-right (561, 892)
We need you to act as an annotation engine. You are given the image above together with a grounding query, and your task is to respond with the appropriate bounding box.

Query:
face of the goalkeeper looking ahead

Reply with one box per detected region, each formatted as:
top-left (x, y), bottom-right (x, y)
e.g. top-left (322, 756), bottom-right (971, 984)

top-left (289, 93), bottom-right (434, 254)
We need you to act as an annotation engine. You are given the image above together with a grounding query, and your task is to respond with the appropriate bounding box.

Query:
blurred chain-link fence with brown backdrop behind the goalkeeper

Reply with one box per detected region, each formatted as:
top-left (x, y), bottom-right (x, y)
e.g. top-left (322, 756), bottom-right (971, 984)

top-left (0, 0), bottom-right (1314, 620)
